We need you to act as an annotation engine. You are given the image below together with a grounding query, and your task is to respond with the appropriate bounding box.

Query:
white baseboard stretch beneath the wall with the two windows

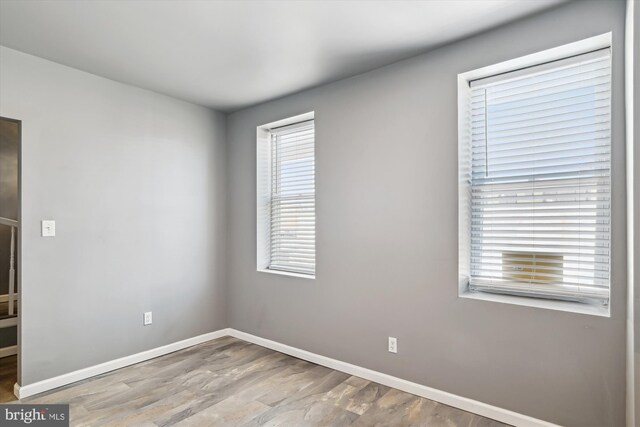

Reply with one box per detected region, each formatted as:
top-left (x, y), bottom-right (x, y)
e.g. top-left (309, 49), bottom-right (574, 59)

top-left (229, 329), bottom-right (557, 427)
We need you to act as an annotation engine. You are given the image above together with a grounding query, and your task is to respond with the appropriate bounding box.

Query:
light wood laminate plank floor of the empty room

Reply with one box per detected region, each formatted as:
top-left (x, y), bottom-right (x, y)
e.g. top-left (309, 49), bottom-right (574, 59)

top-left (20, 337), bottom-right (504, 427)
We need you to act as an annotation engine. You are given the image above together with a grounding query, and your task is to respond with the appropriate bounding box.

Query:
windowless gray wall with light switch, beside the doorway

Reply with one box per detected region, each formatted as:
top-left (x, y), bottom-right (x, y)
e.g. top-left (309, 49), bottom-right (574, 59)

top-left (0, 48), bottom-right (227, 385)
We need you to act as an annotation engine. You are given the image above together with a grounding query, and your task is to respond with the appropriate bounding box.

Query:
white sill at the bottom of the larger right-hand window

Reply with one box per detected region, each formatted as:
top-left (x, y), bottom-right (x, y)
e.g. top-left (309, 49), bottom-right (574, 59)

top-left (459, 289), bottom-right (611, 317)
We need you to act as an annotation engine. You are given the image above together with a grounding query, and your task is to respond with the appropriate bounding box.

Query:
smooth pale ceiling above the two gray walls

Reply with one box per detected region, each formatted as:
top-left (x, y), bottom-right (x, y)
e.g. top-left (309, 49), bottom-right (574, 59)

top-left (0, 0), bottom-right (562, 111)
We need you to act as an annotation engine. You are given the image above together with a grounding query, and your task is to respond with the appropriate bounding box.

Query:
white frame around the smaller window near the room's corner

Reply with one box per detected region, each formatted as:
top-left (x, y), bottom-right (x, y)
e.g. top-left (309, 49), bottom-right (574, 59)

top-left (256, 111), bottom-right (317, 279)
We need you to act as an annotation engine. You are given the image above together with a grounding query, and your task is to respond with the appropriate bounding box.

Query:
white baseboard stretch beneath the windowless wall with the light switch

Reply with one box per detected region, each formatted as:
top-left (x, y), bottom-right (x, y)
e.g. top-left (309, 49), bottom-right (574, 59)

top-left (13, 329), bottom-right (230, 399)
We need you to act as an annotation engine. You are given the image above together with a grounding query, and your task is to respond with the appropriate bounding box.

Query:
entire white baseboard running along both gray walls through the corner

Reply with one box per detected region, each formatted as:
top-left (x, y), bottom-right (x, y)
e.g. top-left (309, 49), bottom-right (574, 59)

top-left (14, 328), bottom-right (557, 427)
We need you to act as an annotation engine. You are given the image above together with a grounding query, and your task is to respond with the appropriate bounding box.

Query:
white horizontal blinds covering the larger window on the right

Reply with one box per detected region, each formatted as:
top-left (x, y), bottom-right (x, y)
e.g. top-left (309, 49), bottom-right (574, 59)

top-left (468, 49), bottom-right (611, 302)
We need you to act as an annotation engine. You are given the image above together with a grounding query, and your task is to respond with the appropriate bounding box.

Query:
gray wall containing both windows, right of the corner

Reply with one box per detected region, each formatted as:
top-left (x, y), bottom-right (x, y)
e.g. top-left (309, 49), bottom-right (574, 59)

top-left (227, 1), bottom-right (626, 427)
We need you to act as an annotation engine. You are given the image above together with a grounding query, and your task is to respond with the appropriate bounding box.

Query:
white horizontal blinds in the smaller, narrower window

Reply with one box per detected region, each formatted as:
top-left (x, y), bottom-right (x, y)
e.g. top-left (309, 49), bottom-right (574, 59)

top-left (268, 120), bottom-right (316, 275)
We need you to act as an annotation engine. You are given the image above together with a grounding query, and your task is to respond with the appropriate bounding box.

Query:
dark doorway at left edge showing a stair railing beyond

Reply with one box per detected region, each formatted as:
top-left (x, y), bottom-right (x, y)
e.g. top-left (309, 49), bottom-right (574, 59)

top-left (0, 117), bottom-right (22, 403)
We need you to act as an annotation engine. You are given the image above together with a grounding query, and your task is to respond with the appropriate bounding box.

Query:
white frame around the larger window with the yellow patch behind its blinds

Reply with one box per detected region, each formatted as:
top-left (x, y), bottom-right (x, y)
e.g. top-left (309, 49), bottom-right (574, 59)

top-left (458, 32), bottom-right (613, 317)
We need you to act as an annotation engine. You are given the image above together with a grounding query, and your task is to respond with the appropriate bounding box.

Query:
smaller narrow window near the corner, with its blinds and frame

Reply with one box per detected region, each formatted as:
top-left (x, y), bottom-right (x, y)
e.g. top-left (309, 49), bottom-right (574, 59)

top-left (258, 115), bottom-right (316, 277)
